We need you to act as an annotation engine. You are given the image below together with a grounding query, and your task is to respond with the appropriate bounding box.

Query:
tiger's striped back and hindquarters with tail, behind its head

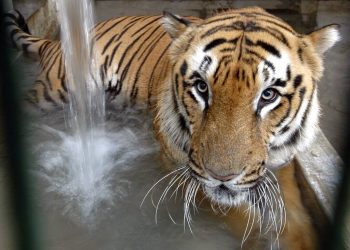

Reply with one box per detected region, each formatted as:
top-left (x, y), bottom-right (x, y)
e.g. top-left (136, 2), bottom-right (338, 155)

top-left (7, 11), bottom-right (196, 111)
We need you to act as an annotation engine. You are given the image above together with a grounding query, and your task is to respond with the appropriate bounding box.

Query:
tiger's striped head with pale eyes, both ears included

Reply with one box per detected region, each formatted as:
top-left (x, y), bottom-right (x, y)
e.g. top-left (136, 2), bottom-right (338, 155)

top-left (158, 8), bottom-right (339, 205)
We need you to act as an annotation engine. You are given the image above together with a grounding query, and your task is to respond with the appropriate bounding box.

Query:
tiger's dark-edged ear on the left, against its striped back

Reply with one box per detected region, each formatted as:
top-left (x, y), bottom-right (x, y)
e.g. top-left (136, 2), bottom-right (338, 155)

top-left (163, 11), bottom-right (191, 39)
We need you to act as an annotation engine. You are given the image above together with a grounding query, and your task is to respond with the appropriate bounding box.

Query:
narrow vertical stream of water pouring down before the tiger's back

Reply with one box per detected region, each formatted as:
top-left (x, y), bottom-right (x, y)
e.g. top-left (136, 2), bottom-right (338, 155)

top-left (57, 0), bottom-right (105, 216)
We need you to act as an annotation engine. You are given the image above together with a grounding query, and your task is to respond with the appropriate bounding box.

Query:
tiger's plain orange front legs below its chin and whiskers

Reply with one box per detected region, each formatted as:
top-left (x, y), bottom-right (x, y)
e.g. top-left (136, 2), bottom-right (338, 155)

top-left (223, 162), bottom-right (317, 250)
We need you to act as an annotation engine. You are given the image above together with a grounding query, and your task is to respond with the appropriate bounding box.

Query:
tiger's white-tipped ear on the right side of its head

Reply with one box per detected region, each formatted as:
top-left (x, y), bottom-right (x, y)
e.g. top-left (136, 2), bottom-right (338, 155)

top-left (308, 24), bottom-right (340, 55)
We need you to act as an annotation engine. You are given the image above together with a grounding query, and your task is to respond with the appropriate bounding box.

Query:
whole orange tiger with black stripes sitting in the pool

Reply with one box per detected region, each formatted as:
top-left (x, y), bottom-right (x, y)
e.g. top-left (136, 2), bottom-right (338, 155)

top-left (6, 7), bottom-right (340, 249)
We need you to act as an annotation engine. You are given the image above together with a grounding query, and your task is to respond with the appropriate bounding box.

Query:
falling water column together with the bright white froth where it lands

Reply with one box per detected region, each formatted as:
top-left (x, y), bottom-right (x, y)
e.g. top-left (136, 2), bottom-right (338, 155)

top-left (52, 0), bottom-right (107, 217)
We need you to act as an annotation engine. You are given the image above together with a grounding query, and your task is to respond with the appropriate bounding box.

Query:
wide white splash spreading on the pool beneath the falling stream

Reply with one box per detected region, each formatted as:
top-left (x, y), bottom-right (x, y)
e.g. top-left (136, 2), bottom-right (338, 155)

top-left (30, 109), bottom-right (159, 221)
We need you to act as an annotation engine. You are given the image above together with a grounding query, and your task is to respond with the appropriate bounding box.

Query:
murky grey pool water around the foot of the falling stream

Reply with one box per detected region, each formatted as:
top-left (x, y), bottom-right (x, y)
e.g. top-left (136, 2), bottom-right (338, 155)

top-left (28, 109), bottom-right (240, 250)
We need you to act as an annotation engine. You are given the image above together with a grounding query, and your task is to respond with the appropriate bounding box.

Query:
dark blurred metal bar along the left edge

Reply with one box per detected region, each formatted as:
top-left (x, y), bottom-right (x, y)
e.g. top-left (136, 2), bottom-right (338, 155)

top-left (0, 4), bottom-right (39, 250)
